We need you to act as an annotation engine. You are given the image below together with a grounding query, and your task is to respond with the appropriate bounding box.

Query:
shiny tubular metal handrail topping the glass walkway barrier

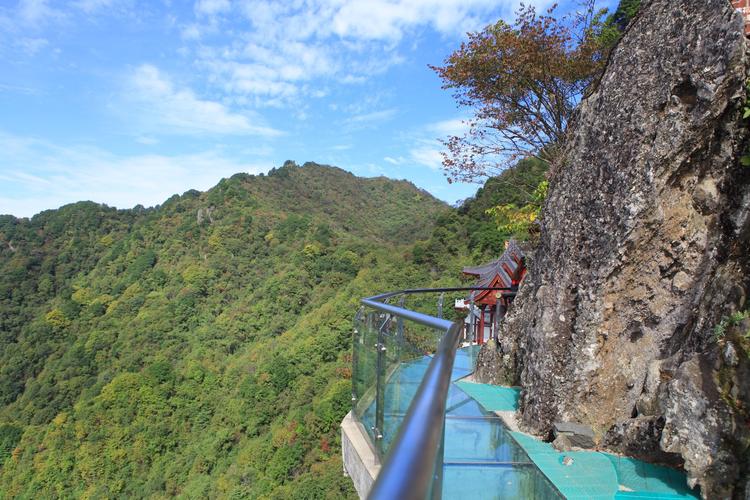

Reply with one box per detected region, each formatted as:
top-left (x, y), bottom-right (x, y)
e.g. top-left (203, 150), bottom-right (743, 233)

top-left (361, 287), bottom-right (516, 500)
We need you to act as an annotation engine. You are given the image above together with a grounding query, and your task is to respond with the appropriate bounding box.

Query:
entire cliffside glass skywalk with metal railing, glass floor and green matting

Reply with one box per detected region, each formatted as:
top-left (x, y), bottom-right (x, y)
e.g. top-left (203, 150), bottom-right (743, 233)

top-left (352, 289), bottom-right (696, 500)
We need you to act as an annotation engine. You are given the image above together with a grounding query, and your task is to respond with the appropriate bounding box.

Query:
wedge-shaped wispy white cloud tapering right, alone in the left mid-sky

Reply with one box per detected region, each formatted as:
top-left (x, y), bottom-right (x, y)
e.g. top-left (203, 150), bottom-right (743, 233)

top-left (125, 64), bottom-right (280, 137)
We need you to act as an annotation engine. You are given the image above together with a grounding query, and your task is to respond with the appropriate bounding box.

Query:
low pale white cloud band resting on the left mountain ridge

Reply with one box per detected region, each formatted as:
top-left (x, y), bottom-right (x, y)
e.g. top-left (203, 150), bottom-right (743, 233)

top-left (0, 133), bottom-right (272, 217)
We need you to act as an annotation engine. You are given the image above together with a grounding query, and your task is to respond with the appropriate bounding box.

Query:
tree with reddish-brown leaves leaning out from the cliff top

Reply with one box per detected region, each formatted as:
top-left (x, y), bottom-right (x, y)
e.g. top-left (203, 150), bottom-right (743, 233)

top-left (431, 0), bottom-right (611, 182)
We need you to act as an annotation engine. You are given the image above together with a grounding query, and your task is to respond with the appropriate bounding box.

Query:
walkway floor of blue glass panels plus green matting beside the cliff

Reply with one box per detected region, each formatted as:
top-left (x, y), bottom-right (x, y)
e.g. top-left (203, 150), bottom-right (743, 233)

top-left (361, 346), bottom-right (697, 500)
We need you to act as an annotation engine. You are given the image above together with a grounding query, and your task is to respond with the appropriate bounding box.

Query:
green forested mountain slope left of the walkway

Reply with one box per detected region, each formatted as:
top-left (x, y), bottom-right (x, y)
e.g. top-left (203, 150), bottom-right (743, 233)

top-left (0, 162), bottom-right (538, 498)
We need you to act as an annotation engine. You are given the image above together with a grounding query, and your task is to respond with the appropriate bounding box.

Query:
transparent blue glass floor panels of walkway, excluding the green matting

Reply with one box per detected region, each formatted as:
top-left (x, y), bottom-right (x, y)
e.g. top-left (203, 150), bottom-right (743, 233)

top-left (362, 346), bottom-right (563, 500)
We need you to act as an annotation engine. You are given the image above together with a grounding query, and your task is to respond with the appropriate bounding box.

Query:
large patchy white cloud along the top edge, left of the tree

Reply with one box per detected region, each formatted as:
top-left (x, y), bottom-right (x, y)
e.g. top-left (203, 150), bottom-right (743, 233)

top-left (182, 0), bottom-right (532, 108)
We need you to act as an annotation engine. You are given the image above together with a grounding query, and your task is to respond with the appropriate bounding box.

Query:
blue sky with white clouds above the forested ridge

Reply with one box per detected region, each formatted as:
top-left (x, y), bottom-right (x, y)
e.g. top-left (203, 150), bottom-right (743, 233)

top-left (0, 0), bottom-right (607, 216)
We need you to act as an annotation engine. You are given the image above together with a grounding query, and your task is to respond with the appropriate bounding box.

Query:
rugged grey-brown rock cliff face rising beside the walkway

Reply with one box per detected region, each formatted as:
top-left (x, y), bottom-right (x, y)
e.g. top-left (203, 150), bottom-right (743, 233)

top-left (478, 0), bottom-right (750, 498)
